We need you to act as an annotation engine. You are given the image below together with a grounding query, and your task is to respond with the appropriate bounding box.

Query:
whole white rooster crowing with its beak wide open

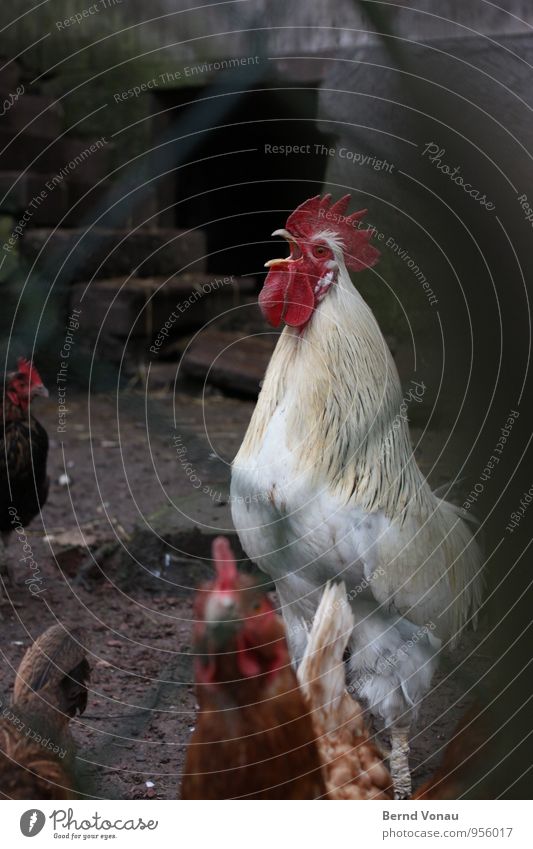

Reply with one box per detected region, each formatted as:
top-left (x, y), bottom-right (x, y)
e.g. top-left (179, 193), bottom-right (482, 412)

top-left (231, 195), bottom-right (482, 797)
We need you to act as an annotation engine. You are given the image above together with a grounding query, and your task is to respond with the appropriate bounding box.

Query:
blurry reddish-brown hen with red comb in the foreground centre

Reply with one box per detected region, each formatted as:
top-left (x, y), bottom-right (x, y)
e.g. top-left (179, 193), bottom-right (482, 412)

top-left (181, 537), bottom-right (326, 799)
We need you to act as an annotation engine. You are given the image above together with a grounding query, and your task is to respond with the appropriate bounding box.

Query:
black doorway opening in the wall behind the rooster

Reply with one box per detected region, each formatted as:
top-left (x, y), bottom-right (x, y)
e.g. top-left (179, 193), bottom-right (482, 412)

top-left (151, 84), bottom-right (331, 275)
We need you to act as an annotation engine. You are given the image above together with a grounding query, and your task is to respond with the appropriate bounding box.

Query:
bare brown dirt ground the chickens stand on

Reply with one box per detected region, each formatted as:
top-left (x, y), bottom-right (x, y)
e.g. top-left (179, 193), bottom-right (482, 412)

top-left (0, 386), bottom-right (488, 799)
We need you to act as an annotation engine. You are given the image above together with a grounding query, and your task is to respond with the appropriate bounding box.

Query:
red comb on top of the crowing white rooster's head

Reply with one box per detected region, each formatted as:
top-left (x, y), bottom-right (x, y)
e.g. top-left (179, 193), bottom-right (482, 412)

top-left (286, 194), bottom-right (379, 271)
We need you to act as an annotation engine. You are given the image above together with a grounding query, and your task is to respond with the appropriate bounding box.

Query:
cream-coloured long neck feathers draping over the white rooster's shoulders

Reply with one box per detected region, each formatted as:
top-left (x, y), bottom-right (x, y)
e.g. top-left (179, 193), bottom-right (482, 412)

top-left (235, 258), bottom-right (434, 517)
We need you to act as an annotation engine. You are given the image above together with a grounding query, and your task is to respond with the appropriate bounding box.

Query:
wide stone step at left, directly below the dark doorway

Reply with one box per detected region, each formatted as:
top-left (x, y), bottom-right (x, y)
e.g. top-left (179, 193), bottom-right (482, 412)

top-left (20, 228), bottom-right (206, 283)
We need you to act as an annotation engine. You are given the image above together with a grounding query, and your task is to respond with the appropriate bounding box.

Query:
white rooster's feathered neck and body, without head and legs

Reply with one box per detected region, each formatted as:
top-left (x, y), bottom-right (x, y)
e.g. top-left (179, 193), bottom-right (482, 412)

top-left (232, 276), bottom-right (480, 641)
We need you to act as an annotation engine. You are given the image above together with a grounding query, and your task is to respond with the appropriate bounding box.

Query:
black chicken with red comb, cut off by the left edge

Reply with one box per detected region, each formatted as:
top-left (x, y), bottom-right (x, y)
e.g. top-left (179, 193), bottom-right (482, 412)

top-left (0, 357), bottom-right (49, 541)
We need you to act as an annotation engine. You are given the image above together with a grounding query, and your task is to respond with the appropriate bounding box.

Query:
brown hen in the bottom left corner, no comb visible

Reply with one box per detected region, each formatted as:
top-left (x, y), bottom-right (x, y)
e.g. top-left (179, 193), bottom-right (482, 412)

top-left (0, 625), bottom-right (90, 799)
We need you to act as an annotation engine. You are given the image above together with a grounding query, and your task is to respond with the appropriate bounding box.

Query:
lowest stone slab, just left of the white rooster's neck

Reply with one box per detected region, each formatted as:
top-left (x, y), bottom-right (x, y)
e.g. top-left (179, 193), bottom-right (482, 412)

top-left (181, 328), bottom-right (278, 398)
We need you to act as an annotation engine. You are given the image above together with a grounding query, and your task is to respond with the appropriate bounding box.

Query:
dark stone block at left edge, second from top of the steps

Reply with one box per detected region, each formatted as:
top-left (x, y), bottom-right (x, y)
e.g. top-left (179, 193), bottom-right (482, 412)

top-left (0, 91), bottom-right (63, 139)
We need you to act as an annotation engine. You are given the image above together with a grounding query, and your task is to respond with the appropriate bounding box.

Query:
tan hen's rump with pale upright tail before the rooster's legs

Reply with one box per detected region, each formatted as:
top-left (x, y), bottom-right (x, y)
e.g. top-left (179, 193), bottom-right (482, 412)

top-left (298, 583), bottom-right (394, 800)
